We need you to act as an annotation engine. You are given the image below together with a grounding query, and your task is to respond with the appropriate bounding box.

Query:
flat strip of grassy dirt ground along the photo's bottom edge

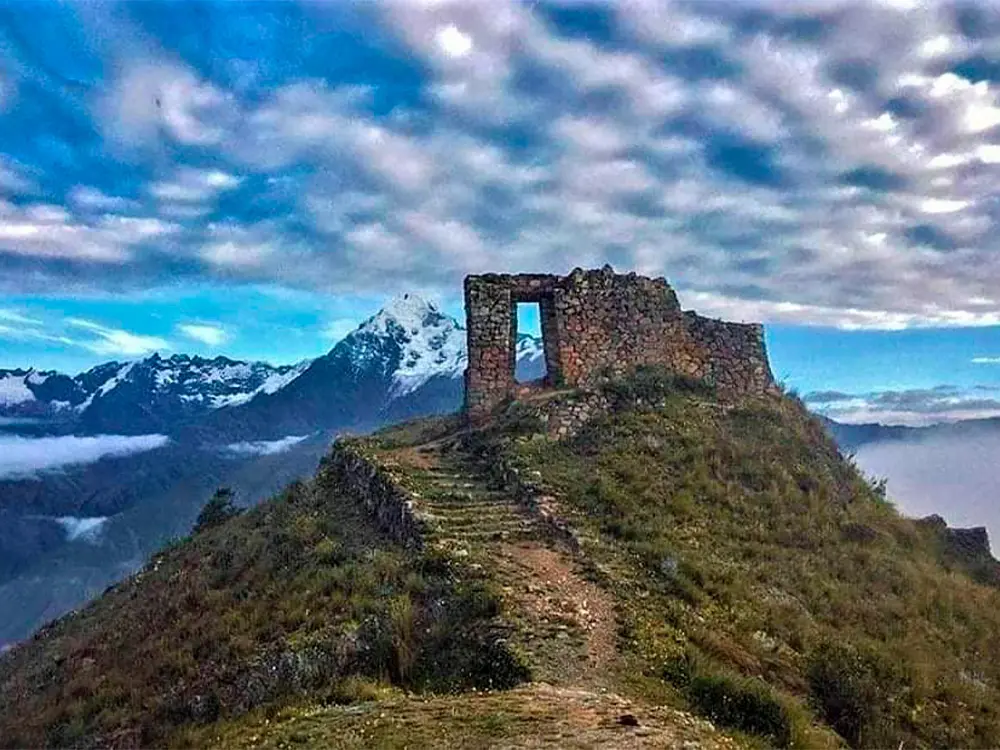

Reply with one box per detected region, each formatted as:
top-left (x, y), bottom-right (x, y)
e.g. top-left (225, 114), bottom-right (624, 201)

top-left (209, 684), bottom-right (738, 750)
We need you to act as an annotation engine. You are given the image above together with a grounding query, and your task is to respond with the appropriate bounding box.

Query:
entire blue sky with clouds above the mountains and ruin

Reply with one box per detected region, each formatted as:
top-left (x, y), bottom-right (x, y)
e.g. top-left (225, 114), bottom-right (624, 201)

top-left (0, 0), bottom-right (1000, 422)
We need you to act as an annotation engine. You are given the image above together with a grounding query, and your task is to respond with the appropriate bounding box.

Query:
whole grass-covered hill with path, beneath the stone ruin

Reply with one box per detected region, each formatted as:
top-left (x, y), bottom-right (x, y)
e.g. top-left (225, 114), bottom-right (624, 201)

top-left (0, 372), bottom-right (1000, 748)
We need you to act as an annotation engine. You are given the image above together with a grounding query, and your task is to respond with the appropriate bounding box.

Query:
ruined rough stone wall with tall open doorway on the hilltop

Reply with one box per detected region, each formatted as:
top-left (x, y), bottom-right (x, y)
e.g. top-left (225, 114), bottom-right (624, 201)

top-left (465, 266), bottom-right (775, 420)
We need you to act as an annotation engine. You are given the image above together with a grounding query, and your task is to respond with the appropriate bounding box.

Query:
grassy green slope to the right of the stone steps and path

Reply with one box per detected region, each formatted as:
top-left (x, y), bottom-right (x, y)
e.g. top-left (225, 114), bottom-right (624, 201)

top-left (493, 373), bottom-right (1000, 748)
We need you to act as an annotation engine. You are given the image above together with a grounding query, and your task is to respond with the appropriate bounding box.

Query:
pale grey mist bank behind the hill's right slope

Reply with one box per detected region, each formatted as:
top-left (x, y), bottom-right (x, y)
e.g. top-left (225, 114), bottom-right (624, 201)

top-left (855, 433), bottom-right (1000, 552)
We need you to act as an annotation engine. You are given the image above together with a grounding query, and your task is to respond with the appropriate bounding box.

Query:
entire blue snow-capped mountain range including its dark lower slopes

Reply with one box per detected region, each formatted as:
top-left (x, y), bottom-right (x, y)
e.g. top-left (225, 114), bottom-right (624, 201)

top-left (0, 294), bottom-right (544, 645)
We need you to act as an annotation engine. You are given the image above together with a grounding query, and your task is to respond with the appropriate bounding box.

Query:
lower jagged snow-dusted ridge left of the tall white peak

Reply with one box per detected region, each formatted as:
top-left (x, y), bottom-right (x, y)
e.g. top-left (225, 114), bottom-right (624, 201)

top-left (0, 354), bottom-right (309, 434)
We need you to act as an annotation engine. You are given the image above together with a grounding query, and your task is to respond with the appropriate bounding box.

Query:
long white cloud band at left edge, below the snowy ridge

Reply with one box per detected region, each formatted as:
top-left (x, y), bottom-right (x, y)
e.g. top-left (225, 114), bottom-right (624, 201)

top-left (0, 435), bottom-right (169, 478)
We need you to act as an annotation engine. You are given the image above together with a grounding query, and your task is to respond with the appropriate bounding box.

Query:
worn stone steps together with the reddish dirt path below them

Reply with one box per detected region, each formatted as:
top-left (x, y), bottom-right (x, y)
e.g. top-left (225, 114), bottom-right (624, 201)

top-left (389, 441), bottom-right (617, 687)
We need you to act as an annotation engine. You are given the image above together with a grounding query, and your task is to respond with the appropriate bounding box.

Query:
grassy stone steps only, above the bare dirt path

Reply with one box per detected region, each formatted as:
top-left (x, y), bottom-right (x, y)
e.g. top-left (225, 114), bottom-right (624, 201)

top-left (404, 455), bottom-right (538, 547)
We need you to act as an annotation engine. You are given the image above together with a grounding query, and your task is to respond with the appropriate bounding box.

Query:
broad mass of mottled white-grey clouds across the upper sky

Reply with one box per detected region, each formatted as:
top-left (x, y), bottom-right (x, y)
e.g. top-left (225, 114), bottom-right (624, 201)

top-left (9, 0), bottom-right (1000, 328)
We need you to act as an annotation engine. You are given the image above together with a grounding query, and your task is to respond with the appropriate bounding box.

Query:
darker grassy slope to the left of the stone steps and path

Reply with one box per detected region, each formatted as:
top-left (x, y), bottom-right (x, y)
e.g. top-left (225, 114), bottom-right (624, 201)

top-left (0, 456), bottom-right (524, 747)
